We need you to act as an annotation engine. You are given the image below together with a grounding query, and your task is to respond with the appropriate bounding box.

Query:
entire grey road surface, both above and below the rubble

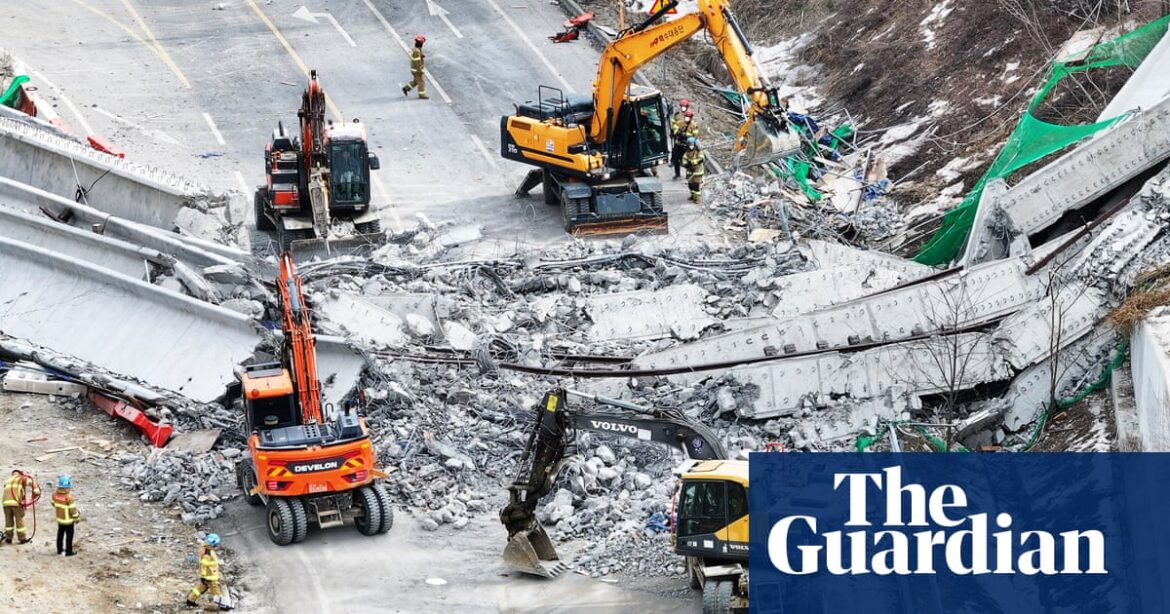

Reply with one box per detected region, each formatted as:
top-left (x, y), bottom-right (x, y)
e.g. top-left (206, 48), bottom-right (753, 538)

top-left (0, 0), bottom-right (715, 613)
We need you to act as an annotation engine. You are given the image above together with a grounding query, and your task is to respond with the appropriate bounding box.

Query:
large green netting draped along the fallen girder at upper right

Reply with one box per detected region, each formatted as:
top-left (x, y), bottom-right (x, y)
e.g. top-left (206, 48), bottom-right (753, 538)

top-left (914, 15), bottom-right (1170, 265)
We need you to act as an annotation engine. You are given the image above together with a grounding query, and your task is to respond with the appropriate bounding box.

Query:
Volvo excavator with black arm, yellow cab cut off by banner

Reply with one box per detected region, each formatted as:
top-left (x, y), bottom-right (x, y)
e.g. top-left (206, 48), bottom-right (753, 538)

top-left (500, 389), bottom-right (748, 614)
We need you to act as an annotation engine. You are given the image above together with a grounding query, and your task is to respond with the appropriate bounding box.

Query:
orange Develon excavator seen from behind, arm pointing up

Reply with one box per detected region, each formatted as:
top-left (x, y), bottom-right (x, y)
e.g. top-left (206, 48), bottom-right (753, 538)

top-left (236, 253), bottom-right (394, 546)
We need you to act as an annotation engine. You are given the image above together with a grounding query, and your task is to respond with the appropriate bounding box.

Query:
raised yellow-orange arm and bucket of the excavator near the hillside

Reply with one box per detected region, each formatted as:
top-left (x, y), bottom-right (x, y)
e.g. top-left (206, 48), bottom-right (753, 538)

top-left (590, 0), bottom-right (799, 165)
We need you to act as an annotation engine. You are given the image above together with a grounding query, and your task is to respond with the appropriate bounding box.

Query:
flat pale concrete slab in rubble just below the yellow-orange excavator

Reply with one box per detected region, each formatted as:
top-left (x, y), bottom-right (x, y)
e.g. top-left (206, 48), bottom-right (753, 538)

top-left (585, 284), bottom-right (716, 340)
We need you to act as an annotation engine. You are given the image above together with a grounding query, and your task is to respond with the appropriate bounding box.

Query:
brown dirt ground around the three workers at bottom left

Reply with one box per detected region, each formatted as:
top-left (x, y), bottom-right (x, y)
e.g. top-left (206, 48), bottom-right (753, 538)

top-left (0, 393), bottom-right (205, 613)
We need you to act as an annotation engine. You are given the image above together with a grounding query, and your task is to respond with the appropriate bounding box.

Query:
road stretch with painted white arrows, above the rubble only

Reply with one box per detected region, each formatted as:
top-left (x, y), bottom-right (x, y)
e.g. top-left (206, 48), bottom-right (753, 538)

top-left (0, 0), bottom-right (715, 246)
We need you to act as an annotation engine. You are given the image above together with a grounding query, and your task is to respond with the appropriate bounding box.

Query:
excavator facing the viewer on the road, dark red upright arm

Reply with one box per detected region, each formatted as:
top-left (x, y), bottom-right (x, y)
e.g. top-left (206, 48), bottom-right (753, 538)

top-left (253, 70), bottom-right (381, 253)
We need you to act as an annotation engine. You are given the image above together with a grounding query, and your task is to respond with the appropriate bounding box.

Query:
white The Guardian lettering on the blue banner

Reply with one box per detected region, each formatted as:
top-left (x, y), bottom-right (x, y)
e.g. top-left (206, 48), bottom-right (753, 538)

top-left (767, 467), bottom-right (1109, 575)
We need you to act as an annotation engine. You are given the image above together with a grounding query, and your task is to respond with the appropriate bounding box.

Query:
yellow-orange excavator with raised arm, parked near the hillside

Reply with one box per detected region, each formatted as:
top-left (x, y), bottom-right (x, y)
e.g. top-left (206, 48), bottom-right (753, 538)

top-left (500, 0), bottom-right (800, 235)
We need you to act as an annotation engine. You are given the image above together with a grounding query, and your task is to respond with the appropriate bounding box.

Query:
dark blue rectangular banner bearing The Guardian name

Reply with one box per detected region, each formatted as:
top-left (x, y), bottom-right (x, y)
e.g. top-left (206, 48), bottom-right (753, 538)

top-left (748, 453), bottom-right (1170, 614)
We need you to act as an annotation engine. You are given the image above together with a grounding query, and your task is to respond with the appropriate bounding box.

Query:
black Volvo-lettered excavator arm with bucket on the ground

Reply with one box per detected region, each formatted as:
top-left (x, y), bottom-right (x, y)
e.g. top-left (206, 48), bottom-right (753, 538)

top-left (500, 389), bottom-right (727, 578)
